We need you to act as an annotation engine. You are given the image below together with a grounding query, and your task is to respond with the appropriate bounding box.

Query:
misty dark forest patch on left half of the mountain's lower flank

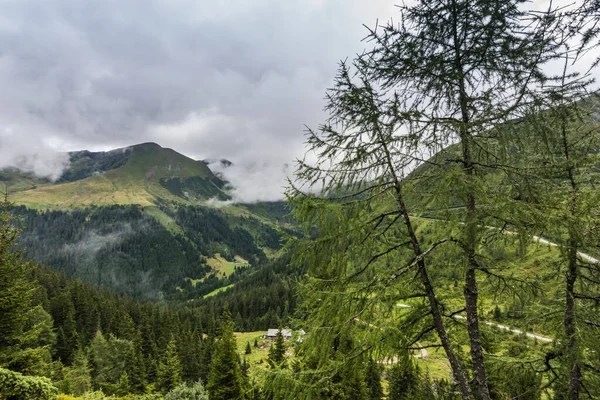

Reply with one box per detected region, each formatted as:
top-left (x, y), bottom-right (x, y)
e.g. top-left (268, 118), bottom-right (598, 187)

top-left (14, 206), bottom-right (210, 299)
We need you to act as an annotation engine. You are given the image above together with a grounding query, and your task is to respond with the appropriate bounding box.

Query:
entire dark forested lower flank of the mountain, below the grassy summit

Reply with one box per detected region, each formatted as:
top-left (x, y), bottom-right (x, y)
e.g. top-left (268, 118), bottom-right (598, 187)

top-left (9, 206), bottom-right (282, 300)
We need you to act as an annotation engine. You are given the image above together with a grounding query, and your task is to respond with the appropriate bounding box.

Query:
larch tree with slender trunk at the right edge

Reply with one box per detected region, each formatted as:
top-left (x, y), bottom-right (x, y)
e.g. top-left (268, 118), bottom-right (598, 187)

top-left (506, 62), bottom-right (600, 400)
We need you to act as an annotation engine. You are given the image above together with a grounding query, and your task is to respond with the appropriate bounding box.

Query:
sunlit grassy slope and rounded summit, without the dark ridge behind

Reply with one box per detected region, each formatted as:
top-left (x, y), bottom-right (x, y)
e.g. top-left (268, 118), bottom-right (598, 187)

top-left (12, 143), bottom-right (223, 208)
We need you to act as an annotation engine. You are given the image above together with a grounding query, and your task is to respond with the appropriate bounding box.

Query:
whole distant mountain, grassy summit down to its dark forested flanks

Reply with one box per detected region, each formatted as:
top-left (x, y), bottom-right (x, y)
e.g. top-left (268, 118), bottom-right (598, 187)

top-left (0, 143), bottom-right (293, 300)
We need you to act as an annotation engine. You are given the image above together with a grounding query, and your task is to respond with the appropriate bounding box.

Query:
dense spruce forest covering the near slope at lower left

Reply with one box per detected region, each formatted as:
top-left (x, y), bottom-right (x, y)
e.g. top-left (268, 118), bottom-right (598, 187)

top-left (0, 192), bottom-right (294, 399)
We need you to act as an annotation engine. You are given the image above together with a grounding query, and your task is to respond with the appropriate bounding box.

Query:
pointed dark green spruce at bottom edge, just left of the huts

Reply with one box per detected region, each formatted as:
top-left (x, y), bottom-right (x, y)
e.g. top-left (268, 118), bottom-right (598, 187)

top-left (206, 309), bottom-right (244, 400)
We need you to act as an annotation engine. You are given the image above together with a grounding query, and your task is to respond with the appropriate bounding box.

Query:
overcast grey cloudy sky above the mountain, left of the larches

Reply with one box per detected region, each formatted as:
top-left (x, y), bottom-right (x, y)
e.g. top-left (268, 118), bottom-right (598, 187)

top-left (0, 0), bottom-right (395, 200)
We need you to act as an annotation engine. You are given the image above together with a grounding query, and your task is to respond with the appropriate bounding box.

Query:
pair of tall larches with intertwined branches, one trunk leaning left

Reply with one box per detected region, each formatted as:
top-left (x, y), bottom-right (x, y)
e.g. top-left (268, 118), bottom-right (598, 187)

top-left (287, 0), bottom-right (580, 400)
